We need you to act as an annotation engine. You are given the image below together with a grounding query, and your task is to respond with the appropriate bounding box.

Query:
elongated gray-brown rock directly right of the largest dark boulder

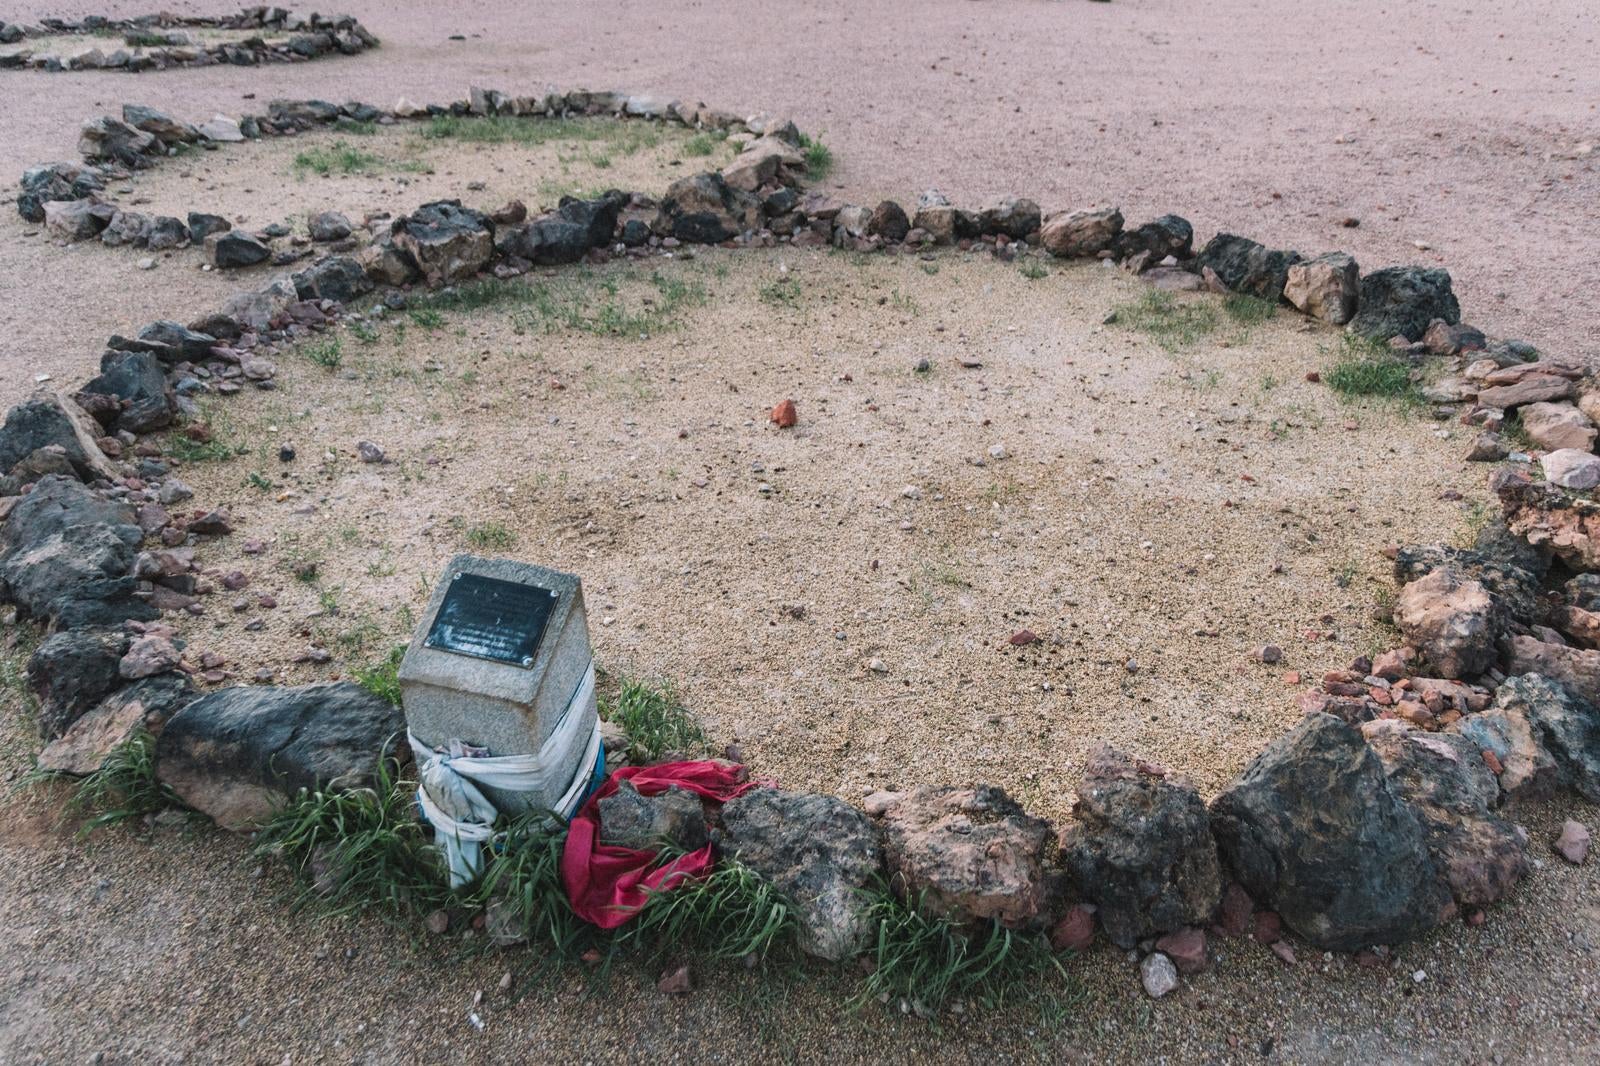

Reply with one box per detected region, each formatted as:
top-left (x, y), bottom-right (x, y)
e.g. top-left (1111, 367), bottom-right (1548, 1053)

top-left (1362, 719), bottom-right (1528, 908)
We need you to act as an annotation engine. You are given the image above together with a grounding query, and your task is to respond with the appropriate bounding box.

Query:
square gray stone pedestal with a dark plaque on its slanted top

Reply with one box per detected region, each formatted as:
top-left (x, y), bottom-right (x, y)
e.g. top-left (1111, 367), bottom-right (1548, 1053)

top-left (400, 555), bottom-right (600, 815)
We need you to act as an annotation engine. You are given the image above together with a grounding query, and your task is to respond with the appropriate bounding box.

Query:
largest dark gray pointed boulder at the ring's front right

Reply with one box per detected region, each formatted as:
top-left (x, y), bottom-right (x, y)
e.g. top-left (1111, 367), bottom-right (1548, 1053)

top-left (1211, 714), bottom-right (1450, 951)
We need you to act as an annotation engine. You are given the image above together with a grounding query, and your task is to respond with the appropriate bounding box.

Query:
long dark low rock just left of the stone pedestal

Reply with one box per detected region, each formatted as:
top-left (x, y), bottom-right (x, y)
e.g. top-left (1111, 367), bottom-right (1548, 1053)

top-left (155, 682), bottom-right (405, 831)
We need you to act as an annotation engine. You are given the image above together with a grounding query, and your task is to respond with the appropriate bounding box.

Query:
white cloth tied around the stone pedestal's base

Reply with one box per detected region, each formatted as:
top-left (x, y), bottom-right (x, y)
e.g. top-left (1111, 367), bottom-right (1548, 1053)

top-left (406, 663), bottom-right (600, 887)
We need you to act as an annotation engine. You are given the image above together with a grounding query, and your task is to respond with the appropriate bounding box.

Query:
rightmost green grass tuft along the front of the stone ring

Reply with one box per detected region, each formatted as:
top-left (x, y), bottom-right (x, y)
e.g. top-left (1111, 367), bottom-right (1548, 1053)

top-left (854, 887), bottom-right (1067, 1018)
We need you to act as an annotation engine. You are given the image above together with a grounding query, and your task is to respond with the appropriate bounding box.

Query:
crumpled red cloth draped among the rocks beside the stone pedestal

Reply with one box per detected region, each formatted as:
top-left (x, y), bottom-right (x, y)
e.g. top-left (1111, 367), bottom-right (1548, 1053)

top-left (562, 760), bottom-right (760, 928)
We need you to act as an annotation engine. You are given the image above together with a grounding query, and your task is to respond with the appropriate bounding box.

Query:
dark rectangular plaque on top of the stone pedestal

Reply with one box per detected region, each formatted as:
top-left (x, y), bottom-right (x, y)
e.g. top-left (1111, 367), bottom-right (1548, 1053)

top-left (422, 573), bottom-right (557, 666)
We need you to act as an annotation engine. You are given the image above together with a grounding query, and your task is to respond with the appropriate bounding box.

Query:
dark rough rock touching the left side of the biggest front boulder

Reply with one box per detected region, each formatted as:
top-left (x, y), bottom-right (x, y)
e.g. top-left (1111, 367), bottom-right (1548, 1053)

top-left (1061, 746), bottom-right (1222, 948)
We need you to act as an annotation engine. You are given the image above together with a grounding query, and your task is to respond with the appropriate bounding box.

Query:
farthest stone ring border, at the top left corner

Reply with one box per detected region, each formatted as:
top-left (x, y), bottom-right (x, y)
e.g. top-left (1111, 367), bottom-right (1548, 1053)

top-left (0, 6), bottom-right (378, 74)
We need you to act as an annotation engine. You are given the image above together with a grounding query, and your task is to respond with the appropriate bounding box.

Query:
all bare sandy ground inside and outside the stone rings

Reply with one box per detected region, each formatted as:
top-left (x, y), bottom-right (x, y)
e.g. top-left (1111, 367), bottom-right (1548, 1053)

top-left (0, 2), bottom-right (1600, 1064)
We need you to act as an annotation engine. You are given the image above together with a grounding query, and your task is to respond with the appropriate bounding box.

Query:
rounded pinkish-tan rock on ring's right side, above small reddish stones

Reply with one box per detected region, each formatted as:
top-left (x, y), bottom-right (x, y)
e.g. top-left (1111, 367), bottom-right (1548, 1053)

top-left (1394, 567), bottom-right (1504, 677)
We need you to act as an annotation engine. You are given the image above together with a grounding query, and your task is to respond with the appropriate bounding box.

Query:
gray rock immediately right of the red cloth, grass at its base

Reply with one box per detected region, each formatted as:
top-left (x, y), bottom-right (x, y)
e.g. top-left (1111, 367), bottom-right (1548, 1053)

top-left (717, 789), bottom-right (883, 962)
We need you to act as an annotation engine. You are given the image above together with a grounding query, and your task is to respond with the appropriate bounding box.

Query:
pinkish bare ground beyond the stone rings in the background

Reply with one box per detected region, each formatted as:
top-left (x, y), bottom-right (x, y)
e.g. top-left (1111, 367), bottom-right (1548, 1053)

top-left (0, 0), bottom-right (1600, 402)
